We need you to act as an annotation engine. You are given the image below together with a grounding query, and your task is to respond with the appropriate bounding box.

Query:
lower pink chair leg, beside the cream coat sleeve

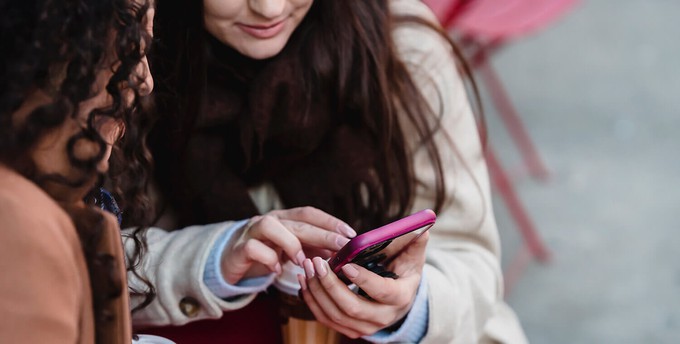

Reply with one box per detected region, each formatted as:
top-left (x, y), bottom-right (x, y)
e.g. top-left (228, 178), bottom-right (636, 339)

top-left (486, 146), bottom-right (550, 262)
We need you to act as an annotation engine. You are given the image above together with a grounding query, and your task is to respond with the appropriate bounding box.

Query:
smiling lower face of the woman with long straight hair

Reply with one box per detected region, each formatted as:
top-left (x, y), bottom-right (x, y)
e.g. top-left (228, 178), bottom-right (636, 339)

top-left (203, 0), bottom-right (314, 60)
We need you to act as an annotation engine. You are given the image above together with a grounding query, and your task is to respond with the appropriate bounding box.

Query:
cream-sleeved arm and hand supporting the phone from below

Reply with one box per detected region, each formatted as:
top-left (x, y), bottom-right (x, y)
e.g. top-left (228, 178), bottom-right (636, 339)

top-left (303, 0), bottom-right (523, 343)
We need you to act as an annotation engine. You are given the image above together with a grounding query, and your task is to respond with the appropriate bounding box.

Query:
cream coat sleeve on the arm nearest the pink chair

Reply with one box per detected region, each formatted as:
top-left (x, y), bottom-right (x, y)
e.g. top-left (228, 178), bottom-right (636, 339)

top-left (394, 0), bottom-right (523, 343)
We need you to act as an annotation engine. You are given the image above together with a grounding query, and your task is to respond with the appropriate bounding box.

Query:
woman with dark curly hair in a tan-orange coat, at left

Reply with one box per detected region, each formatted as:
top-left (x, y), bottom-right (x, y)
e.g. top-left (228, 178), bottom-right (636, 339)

top-left (0, 0), bottom-right (153, 344)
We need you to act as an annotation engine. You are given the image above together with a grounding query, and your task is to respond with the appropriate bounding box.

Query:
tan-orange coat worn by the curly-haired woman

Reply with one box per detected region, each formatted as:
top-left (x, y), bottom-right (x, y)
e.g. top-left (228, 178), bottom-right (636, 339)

top-left (0, 164), bottom-right (132, 344)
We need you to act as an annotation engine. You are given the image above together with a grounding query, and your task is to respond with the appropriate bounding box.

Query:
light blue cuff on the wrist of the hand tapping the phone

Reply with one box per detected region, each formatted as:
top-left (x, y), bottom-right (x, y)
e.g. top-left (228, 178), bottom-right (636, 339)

top-left (203, 220), bottom-right (275, 299)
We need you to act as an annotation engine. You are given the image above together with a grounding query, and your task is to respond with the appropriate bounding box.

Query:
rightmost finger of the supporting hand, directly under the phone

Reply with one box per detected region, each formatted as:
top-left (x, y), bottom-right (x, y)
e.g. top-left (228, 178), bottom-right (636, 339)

top-left (342, 263), bottom-right (420, 308)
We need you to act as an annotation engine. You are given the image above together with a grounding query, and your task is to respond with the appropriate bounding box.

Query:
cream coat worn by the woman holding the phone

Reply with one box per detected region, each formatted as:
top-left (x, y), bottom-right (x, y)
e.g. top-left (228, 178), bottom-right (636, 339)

top-left (130, 0), bottom-right (526, 344)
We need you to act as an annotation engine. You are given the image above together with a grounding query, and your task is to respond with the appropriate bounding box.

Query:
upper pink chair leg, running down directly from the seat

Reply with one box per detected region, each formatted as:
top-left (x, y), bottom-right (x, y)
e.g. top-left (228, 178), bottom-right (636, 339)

top-left (475, 47), bottom-right (549, 180)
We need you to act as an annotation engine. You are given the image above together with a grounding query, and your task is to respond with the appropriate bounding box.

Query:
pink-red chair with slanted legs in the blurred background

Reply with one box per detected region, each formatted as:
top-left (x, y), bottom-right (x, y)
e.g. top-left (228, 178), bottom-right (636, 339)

top-left (423, 0), bottom-right (577, 266)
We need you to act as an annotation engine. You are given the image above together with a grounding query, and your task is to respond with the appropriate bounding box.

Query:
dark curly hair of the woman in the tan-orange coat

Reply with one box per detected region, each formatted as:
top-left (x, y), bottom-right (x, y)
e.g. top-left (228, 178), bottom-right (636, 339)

top-left (0, 0), bottom-right (152, 342)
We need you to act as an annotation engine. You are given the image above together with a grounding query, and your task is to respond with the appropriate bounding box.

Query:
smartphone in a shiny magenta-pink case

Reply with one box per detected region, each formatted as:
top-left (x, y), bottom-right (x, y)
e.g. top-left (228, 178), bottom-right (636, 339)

top-left (328, 209), bottom-right (437, 282)
